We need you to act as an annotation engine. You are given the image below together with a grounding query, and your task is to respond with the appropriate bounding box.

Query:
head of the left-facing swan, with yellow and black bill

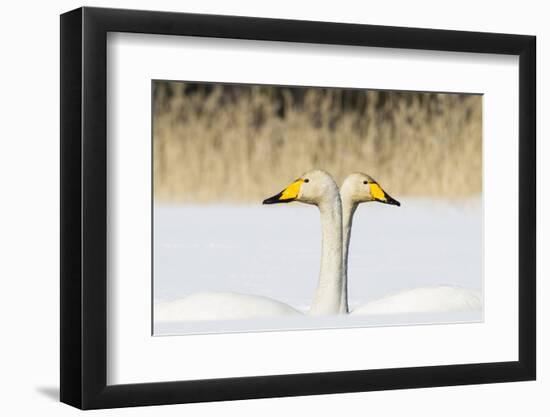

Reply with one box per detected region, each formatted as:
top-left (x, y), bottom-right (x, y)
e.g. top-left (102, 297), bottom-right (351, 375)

top-left (263, 169), bottom-right (339, 206)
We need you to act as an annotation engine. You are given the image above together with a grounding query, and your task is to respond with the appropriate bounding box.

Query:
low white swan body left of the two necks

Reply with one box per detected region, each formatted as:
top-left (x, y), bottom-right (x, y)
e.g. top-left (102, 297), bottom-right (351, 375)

top-left (155, 291), bottom-right (302, 322)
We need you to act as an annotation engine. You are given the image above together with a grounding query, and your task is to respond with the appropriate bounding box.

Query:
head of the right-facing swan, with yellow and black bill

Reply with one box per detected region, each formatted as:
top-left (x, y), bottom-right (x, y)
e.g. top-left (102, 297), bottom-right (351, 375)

top-left (340, 172), bottom-right (401, 206)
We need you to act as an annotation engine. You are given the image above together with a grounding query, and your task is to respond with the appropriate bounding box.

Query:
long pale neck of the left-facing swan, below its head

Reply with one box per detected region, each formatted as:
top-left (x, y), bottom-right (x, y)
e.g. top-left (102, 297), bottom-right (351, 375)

top-left (310, 192), bottom-right (348, 315)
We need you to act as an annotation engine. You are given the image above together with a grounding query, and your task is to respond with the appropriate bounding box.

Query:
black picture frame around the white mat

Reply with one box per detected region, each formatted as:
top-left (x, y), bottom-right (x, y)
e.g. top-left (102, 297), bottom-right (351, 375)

top-left (60, 7), bottom-right (536, 409)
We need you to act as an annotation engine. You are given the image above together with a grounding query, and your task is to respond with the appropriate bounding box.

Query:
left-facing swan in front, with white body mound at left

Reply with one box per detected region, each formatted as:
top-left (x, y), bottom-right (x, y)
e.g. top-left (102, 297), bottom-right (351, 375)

top-left (154, 171), bottom-right (347, 321)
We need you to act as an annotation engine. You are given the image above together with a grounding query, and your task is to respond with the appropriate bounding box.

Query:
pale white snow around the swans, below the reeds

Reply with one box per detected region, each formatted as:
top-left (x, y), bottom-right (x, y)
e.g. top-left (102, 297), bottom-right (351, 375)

top-left (153, 199), bottom-right (483, 335)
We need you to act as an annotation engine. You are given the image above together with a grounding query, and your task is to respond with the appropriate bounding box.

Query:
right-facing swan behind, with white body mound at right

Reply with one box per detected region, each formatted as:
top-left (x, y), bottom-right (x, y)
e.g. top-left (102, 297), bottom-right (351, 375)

top-left (340, 173), bottom-right (481, 314)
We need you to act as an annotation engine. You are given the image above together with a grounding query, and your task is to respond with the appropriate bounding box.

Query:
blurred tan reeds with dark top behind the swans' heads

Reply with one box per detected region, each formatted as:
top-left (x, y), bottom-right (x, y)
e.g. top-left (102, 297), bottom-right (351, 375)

top-left (153, 81), bottom-right (482, 203)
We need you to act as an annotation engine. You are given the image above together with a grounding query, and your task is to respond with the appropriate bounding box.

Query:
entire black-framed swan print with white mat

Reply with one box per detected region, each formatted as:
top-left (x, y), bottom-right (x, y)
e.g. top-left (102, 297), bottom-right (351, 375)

top-left (61, 8), bottom-right (536, 409)
